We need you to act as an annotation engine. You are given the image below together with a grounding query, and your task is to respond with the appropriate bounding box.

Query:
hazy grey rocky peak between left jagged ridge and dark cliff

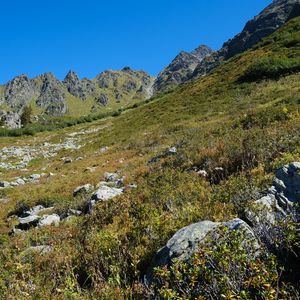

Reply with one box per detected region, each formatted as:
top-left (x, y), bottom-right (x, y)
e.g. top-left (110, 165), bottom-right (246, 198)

top-left (153, 45), bottom-right (213, 93)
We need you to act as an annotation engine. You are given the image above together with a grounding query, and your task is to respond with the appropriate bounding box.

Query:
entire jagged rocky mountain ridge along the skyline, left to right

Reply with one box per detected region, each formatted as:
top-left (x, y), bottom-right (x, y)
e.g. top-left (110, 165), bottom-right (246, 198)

top-left (0, 0), bottom-right (300, 127)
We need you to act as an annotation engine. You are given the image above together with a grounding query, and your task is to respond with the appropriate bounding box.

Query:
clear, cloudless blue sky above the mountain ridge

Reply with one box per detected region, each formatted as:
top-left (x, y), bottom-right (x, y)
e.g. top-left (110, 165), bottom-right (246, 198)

top-left (0, 0), bottom-right (272, 83)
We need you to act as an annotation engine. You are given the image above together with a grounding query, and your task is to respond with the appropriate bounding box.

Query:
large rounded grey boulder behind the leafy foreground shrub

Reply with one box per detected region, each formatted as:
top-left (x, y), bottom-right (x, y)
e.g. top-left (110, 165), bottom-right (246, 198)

top-left (146, 219), bottom-right (259, 283)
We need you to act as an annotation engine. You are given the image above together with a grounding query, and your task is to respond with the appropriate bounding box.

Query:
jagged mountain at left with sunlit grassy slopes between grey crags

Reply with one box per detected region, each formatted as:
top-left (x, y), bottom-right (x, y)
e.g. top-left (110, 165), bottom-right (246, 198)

top-left (0, 67), bottom-right (153, 120)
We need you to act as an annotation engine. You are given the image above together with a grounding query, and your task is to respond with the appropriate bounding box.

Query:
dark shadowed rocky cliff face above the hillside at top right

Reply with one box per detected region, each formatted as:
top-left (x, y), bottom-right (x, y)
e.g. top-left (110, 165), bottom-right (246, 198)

top-left (191, 0), bottom-right (300, 78)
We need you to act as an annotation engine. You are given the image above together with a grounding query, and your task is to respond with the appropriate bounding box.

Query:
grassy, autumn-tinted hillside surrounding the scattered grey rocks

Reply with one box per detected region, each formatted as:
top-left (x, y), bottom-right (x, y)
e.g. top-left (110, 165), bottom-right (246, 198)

top-left (0, 18), bottom-right (300, 299)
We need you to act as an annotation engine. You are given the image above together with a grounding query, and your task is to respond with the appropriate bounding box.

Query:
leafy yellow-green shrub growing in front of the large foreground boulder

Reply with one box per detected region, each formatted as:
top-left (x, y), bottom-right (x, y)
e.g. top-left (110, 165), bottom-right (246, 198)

top-left (153, 227), bottom-right (279, 299)
